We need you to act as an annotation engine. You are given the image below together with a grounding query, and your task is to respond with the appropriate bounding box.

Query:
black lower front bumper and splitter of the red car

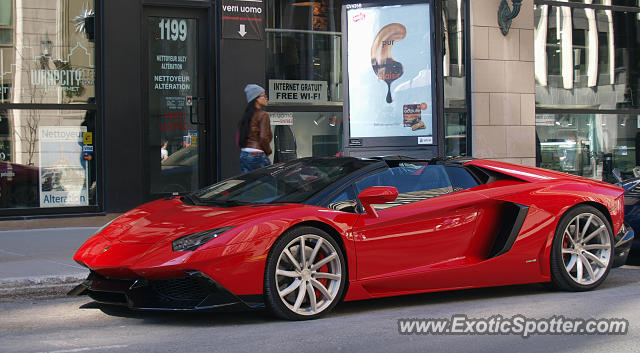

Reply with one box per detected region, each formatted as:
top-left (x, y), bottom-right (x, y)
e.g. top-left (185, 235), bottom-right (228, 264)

top-left (68, 271), bottom-right (264, 310)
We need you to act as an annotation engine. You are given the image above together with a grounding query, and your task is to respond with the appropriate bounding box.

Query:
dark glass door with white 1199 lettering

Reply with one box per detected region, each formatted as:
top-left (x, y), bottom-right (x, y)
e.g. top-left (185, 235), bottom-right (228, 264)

top-left (145, 9), bottom-right (207, 195)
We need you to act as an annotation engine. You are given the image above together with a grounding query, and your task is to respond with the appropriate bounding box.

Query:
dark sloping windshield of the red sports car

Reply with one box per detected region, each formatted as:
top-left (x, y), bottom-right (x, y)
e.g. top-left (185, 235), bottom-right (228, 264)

top-left (192, 157), bottom-right (375, 206)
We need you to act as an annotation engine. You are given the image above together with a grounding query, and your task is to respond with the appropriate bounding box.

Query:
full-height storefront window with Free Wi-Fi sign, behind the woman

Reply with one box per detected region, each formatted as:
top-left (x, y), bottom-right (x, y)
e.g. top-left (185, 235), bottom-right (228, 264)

top-left (265, 0), bottom-right (343, 163)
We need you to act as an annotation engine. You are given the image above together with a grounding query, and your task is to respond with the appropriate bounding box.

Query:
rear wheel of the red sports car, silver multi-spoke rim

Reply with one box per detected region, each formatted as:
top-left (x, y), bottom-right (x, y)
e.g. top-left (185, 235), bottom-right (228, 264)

top-left (551, 205), bottom-right (613, 291)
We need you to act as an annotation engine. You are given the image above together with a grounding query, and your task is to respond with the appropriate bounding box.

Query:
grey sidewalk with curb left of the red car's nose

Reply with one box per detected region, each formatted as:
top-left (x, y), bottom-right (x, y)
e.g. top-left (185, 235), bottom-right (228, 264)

top-left (0, 214), bottom-right (117, 301)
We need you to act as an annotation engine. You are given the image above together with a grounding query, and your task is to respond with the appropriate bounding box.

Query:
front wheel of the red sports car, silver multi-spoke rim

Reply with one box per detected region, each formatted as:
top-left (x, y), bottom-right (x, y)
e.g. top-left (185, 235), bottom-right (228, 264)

top-left (264, 227), bottom-right (347, 320)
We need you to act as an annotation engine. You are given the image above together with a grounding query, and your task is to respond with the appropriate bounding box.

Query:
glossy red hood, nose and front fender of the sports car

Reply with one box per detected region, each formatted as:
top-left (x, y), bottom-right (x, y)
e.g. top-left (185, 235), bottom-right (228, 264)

top-left (74, 199), bottom-right (359, 295)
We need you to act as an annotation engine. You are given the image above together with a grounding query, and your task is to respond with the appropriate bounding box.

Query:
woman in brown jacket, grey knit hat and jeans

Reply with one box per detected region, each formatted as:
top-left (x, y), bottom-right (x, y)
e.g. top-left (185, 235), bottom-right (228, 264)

top-left (238, 84), bottom-right (273, 173)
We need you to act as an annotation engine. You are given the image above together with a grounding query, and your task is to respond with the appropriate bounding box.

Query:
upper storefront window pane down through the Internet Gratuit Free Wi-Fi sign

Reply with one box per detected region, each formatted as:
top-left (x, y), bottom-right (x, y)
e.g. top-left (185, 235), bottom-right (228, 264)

top-left (265, 0), bottom-right (342, 105)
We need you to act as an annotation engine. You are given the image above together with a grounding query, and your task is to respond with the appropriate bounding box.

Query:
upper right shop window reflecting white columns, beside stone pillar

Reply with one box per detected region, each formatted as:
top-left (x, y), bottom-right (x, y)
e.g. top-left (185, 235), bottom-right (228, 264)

top-left (534, 1), bottom-right (640, 109)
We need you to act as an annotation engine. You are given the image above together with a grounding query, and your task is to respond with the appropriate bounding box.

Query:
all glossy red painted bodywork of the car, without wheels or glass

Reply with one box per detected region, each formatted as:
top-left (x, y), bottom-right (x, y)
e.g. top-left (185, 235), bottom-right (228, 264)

top-left (74, 160), bottom-right (624, 300)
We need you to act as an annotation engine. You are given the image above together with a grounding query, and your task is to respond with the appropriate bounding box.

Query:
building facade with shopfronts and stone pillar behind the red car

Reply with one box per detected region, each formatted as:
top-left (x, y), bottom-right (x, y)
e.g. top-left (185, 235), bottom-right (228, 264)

top-left (0, 0), bottom-right (640, 219)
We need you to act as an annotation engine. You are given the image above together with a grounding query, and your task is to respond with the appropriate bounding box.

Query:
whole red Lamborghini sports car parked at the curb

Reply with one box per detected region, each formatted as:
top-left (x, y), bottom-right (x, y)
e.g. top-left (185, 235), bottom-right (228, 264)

top-left (70, 157), bottom-right (633, 320)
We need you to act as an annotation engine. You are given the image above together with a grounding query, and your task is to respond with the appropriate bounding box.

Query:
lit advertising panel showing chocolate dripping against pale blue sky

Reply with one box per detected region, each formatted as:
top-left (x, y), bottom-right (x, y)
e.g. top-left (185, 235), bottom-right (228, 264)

top-left (345, 2), bottom-right (436, 145)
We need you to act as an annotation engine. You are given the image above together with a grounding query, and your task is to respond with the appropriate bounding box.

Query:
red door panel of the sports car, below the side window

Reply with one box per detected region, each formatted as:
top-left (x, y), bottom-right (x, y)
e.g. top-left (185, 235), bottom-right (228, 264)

top-left (353, 187), bottom-right (486, 281)
